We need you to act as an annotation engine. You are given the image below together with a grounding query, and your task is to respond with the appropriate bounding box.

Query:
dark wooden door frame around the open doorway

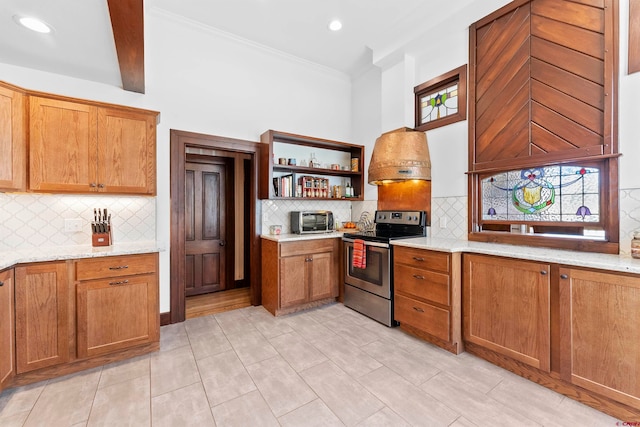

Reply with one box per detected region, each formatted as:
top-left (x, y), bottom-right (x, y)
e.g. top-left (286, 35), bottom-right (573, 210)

top-left (169, 129), bottom-right (262, 323)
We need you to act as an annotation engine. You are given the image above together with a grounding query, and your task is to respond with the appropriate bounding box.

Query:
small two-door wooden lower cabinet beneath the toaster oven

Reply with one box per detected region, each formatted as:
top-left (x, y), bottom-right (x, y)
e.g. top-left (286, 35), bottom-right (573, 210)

top-left (262, 238), bottom-right (341, 315)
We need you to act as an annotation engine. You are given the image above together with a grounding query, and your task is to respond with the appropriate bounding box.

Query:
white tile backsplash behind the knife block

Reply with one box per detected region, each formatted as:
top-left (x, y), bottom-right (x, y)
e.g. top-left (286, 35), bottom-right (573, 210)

top-left (0, 193), bottom-right (156, 251)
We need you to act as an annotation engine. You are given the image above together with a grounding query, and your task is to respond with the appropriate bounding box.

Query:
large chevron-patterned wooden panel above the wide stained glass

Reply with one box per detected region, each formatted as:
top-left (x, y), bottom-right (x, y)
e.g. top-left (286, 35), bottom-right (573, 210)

top-left (469, 0), bottom-right (617, 171)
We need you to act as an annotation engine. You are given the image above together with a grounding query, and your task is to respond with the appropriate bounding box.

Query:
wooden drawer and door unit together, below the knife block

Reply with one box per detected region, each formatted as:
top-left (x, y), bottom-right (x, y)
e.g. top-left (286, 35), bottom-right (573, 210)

top-left (74, 254), bottom-right (160, 358)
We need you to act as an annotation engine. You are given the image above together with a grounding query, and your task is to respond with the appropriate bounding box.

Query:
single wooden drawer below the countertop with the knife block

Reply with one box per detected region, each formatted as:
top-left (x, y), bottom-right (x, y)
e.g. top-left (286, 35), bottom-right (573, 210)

top-left (75, 253), bottom-right (157, 281)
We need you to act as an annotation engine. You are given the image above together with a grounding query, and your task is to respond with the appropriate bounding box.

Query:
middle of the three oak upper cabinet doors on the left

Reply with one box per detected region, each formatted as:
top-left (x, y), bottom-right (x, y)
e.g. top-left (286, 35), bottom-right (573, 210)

top-left (29, 96), bottom-right (97, 193)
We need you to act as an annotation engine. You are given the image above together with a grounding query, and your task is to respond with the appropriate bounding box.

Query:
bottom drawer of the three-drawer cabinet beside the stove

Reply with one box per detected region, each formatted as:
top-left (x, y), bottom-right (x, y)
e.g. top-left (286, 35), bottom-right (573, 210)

top-left (394, 295), bottom-right (451, 341)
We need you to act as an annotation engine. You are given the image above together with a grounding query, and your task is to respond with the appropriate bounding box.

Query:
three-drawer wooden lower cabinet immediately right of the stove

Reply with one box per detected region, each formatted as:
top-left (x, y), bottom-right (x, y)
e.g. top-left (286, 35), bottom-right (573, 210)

top-left (393, 246), bottom-right (463, 354)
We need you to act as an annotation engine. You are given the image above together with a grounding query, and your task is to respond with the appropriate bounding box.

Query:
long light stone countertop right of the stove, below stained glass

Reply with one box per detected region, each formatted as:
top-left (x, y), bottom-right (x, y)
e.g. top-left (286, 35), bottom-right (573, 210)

top-left (392, 237), bottom-right (640, 274)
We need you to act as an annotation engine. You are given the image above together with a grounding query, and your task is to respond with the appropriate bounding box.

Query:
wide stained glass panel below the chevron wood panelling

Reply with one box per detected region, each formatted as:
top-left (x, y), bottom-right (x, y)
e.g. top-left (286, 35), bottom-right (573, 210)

top-left (482, 166), bottom-right (600, 223)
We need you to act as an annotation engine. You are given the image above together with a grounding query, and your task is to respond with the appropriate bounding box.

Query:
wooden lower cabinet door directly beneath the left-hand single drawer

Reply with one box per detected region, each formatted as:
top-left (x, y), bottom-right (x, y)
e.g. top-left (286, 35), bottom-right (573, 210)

top-left (76, 274), bottom-right (160, 358)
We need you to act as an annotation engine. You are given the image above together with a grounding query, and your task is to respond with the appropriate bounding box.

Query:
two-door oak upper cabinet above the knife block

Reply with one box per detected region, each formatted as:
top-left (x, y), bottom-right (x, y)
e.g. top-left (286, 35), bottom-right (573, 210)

top-left (29, 96), bottom-right (157, 194)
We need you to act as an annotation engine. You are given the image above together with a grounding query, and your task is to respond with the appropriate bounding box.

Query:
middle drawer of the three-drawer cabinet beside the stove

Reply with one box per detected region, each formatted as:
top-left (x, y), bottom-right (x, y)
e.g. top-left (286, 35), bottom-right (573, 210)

top-left (393, 265), bottom-right (451, 306)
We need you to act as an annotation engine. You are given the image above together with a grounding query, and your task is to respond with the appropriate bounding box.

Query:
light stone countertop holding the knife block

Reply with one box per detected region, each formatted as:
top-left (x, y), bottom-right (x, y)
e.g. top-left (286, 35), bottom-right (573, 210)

top-left (0, 241), bottom-right (164, 270)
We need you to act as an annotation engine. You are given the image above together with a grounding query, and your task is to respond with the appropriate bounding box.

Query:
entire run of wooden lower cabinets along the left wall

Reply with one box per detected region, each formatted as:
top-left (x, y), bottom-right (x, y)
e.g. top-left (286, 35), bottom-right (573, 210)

top-left (5, 253), bottom-right (160, 389)
